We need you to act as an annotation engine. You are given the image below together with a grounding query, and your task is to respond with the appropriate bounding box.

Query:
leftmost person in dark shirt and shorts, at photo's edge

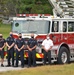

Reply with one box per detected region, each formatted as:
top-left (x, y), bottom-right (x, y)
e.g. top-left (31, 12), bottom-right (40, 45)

top-left (0, 34), bottom-right (5, 67)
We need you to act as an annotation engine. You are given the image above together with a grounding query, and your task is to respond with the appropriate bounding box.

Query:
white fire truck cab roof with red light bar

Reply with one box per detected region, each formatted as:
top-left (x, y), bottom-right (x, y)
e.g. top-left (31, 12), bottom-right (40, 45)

top-left (13, 14), bottom-right (74, 20)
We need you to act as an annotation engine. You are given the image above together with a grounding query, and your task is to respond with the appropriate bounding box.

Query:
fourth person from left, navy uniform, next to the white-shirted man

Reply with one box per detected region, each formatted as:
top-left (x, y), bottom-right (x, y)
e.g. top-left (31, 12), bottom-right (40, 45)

top-left (27, 33), bottom-right (37, 67)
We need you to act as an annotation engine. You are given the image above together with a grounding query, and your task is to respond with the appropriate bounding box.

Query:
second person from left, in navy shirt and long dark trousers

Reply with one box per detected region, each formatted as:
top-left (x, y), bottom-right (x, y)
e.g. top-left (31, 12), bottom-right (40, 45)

top-left (6, 32), bottom-right (15, 67)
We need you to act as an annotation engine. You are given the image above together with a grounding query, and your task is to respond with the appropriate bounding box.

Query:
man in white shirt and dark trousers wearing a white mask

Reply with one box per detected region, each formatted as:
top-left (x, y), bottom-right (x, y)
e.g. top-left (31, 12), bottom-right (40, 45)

top-left (42, 35), bottom-right (53, 65)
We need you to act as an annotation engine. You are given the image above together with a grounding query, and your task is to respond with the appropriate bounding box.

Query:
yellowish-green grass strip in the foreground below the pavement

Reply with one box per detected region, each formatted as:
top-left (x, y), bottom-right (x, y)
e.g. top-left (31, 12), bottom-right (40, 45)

top-left (0, 63), bottom-right (74, 75)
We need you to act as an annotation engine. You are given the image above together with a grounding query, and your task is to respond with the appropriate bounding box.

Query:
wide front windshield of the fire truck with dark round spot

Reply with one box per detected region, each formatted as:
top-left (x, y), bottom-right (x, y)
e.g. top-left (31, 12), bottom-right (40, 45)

top-left (12, 20), bottom-right (50, 34)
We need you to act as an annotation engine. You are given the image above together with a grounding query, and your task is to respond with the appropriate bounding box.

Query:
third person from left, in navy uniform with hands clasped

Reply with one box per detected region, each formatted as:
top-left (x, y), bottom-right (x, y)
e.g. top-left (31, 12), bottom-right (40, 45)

top-left (15, 33), bottom-right (25, 68)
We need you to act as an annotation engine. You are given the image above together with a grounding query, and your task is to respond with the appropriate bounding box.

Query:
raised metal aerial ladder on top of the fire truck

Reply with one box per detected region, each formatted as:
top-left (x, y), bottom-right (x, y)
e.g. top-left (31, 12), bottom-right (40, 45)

top-left (48, 0), bottom-right (74, 18)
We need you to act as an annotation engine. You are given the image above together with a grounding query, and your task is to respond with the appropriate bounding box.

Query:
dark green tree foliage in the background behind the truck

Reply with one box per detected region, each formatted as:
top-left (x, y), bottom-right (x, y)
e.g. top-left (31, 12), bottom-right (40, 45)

top-left (0, 0), bottom-right (52, 16)
